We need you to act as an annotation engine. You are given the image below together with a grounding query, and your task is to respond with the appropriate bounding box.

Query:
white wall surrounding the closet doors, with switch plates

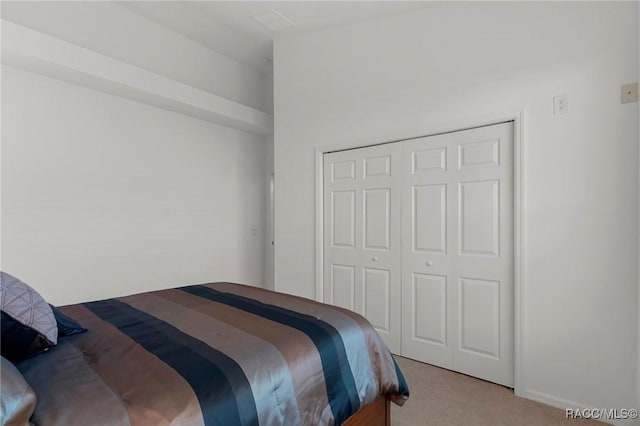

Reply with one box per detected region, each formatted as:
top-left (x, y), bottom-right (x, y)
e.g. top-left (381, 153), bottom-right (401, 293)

top-left (274, 2), bottom-right (639, 418)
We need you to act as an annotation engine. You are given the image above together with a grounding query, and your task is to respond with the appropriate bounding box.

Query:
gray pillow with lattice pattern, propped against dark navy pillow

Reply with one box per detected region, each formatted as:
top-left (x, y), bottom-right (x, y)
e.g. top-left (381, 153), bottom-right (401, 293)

top-left (0, 272), bottom-right (58, 345)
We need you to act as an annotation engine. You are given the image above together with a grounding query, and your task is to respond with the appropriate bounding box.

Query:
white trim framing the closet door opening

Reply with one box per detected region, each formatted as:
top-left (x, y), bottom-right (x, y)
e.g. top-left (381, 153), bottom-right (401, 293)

top-left (315, 108), bottom-right (527, 397)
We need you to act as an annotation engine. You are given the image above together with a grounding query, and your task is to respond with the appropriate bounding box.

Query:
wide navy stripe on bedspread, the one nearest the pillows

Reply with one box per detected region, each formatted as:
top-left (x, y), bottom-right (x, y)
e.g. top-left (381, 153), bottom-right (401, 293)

top-left (83, 299), bottom-right (258, 426)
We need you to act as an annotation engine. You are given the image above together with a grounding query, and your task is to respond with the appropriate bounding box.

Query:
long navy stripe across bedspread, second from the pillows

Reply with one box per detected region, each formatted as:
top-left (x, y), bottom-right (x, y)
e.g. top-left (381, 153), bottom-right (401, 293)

top-left (178, 285), bottom-right (360, 425)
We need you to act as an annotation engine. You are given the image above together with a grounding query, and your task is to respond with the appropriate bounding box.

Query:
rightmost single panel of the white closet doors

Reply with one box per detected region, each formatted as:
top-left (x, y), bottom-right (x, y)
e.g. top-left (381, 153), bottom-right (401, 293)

top-left (453, 123), bottom-right (514, 387)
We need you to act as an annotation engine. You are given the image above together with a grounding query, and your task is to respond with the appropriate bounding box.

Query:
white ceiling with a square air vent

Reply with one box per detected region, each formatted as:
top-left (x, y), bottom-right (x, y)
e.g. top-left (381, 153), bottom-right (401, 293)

top-left (119, 1), bottom-right (428, 72)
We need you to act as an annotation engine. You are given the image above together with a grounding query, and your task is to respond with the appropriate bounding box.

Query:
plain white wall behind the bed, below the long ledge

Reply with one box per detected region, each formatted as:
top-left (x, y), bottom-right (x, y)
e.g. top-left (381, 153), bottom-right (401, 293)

top-left (1, 66), bottom-right (265, 304)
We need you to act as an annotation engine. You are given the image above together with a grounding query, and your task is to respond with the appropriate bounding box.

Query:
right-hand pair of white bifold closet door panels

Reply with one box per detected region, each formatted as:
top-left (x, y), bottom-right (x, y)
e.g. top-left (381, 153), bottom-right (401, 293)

top-left (402, 123), bottom-right (513, 386)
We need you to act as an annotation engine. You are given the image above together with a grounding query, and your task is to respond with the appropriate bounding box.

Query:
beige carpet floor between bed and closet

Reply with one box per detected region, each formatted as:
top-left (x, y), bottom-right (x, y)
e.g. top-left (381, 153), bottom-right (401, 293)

top-left (391, 357), bottom-right (604, 426)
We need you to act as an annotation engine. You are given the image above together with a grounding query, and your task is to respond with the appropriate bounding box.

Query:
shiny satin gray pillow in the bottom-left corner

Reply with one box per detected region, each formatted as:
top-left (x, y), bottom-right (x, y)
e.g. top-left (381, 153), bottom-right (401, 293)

top-left (0, 358), bottom-right (36, 426)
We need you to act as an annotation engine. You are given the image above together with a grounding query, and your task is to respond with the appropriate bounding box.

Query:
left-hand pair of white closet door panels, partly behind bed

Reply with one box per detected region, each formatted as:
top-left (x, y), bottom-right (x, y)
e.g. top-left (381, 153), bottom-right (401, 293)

top-left (323, 144), bottom-right (402, 354)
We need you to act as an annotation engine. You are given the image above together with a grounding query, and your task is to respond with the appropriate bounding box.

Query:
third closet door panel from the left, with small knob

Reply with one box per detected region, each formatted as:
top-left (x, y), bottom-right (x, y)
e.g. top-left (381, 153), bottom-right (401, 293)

top-left (402, 134), bottom-right (456, 369)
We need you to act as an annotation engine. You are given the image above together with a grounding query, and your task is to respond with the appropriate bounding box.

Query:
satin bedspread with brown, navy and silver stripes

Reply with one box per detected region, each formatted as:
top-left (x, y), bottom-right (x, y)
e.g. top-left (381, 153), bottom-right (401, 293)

top-left (17, 283), bottom-right (409, 426)
